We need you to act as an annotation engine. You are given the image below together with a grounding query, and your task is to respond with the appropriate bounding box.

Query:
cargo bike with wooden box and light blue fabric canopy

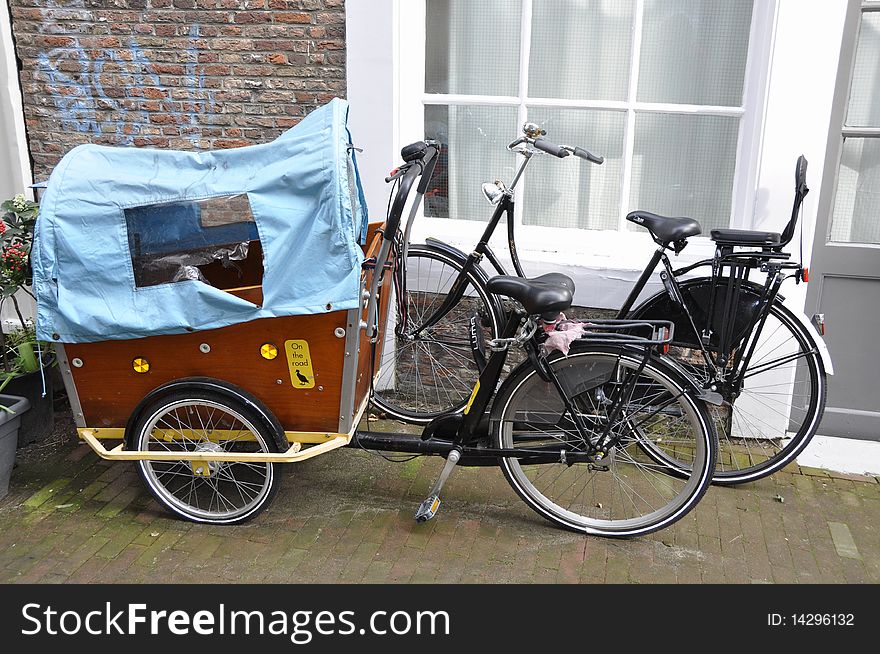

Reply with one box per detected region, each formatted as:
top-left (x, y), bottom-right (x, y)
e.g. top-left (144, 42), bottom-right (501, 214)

top-left (33, 100), bottom-right (716, 537)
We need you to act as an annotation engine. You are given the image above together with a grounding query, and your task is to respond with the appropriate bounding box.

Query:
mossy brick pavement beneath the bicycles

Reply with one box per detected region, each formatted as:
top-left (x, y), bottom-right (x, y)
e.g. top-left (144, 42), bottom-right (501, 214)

top-left (0, 414), bottom-right (880, 583)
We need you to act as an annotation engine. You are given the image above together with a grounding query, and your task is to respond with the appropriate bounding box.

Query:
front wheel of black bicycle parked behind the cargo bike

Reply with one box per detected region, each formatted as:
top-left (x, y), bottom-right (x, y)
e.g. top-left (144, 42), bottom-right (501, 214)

top-left (373, 245), bottom-right (500, 424)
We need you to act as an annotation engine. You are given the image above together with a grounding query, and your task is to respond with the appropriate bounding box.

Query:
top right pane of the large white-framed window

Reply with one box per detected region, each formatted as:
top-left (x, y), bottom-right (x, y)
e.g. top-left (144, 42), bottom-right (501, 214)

top-left (638, 0), bottom-right (752, 107)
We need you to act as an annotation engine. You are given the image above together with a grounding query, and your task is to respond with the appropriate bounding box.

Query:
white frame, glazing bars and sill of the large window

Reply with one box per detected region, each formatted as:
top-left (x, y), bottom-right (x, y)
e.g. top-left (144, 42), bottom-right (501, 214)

top-left (395, 0), bottom-right (778, 270)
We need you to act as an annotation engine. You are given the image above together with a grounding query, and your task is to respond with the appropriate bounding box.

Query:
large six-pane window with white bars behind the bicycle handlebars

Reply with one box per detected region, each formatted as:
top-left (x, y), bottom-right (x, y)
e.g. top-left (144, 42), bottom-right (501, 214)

top-left (423, 0), bottom-right (755, 233)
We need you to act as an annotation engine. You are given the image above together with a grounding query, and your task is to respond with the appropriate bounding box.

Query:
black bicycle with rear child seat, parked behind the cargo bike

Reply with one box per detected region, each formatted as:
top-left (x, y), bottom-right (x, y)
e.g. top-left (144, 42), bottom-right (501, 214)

top-left (374, 123), bottom-right (832, 484)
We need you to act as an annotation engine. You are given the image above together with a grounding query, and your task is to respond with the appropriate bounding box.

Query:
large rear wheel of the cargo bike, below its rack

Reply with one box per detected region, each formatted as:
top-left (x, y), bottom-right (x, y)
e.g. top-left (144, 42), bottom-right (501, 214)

top-left (493, 348), bottom-right (716, 537)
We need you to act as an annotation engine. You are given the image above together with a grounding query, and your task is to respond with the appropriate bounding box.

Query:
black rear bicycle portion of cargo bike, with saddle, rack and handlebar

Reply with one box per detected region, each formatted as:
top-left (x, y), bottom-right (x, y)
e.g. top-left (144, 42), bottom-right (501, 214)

top-left (350, 143), bottom-right (717, 537)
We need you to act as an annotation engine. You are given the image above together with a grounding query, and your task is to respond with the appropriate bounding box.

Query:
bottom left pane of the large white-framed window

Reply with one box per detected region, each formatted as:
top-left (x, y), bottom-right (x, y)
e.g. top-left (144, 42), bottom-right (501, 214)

top-left (425, 105), bottom-right (519, 221)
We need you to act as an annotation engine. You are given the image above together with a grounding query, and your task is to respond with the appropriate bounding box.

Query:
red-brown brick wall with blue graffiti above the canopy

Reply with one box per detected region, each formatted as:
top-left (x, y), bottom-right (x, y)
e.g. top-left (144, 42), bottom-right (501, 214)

top-left (6, 0), bottom-right (345, 180)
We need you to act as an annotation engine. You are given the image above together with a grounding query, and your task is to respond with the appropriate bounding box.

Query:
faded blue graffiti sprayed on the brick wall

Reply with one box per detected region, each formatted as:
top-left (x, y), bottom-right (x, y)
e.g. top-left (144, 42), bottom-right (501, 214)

top-left (39, 25), bottom-right (216, 145)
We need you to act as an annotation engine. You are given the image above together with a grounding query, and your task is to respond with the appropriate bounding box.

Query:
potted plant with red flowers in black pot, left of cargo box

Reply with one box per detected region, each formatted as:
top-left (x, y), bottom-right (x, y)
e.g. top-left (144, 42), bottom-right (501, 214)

top-left (0, 195), bottom-right (55, 445)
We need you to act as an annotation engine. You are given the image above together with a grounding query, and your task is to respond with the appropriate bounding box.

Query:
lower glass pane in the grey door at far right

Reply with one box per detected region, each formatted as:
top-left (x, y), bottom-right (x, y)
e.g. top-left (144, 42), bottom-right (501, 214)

top-left (831, 138), bottom-right (880, 243)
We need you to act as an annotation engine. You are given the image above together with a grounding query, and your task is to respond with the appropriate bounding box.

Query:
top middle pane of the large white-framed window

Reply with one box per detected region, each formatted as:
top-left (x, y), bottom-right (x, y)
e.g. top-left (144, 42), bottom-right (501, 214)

top-left (529, 0), bottom-right (634, 100)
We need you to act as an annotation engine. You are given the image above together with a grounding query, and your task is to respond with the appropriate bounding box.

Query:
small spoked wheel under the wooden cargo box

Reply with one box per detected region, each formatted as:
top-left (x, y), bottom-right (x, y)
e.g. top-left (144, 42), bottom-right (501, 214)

top-left (126, 383), bottom-right (279, 525)
